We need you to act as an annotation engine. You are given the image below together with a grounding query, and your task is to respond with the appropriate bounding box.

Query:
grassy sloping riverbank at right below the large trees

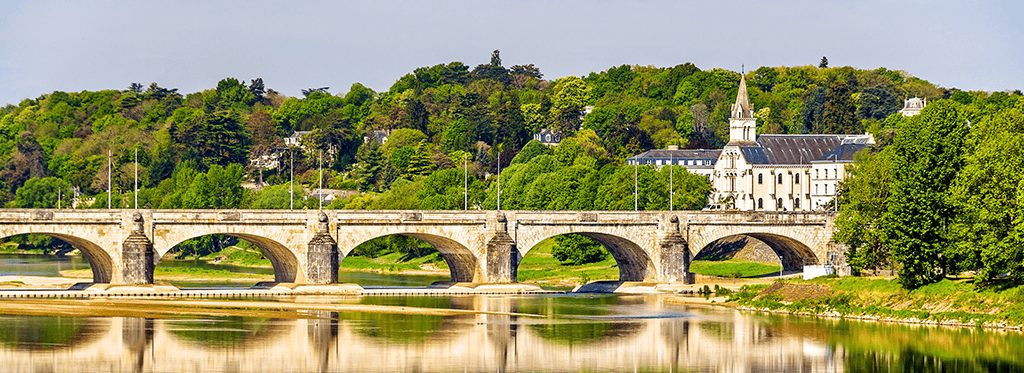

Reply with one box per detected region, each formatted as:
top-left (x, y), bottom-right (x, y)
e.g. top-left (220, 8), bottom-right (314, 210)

top-left (725, 277), bottom-right (1024, 331)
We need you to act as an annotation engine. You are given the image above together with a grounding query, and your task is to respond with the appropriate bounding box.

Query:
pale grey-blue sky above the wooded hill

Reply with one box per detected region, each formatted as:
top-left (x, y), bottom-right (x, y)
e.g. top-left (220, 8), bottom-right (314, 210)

top-left (0, 0), bottom-right (1024, 107)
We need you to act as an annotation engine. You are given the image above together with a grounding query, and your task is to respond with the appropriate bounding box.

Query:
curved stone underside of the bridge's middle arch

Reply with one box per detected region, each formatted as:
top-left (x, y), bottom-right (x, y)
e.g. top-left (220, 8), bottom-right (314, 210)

top-left (338, 231), bottom-right (475, 282)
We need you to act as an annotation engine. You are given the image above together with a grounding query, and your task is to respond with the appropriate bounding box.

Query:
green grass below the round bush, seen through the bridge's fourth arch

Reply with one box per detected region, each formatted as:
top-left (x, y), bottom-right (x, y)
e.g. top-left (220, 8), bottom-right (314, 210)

top-left (518, 239), bottom-right (618, 283)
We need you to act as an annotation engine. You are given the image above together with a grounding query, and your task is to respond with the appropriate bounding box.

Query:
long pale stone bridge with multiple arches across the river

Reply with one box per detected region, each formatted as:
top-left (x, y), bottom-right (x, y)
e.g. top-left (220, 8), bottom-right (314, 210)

top-left (0, 209), bottom-right (841, 284)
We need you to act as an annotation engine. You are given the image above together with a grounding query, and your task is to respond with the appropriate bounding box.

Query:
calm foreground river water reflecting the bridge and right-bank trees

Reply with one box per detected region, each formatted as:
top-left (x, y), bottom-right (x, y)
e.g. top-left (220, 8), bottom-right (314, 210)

top-left (0, 252), bottom-right (1024, 372)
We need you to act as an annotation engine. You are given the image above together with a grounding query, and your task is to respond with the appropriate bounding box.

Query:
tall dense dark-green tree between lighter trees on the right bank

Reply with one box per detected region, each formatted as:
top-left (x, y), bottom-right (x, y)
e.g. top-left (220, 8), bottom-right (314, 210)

top-left (882, 100), bottom-right (969, 289)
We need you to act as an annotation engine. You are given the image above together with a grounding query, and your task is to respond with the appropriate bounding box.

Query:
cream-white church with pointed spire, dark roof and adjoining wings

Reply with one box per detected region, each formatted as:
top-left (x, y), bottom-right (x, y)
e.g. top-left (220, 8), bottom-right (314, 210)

top-left (628, 72), bottom-right (874, 211)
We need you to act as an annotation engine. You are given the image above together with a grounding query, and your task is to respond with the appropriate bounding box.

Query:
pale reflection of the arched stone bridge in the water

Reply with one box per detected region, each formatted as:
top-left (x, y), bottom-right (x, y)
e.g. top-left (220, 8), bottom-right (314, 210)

top-left (0, 296), bottom-right (842, 372)
